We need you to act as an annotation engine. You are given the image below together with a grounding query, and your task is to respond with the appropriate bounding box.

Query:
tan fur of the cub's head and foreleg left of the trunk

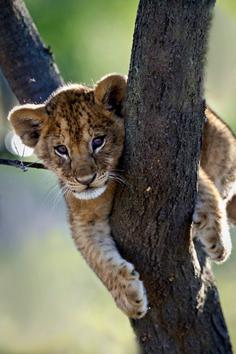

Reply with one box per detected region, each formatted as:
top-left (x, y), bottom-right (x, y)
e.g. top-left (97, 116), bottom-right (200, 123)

top-left (9, 75), bottom-right (147, 318)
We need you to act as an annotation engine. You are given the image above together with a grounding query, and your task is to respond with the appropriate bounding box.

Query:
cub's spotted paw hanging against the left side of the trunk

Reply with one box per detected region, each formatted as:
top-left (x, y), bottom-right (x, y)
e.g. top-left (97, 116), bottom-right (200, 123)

top-left (111, 262), bottom-right (148, 319)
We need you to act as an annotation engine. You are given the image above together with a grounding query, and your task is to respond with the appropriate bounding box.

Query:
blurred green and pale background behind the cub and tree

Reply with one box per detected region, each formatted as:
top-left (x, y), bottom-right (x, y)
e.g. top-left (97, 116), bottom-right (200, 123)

top-left (0, 0), bottom-right (236, 354)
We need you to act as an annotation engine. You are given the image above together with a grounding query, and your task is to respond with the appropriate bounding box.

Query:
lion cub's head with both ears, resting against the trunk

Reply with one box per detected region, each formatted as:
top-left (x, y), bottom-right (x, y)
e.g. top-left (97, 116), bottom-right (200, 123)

top-left (9, 75), bottom-right (126, 199)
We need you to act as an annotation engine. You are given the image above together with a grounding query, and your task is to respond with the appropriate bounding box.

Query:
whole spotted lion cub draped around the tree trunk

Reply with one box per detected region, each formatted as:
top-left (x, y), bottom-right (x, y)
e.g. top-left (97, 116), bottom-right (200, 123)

top-left (9, 74), bottom-right (236, 318)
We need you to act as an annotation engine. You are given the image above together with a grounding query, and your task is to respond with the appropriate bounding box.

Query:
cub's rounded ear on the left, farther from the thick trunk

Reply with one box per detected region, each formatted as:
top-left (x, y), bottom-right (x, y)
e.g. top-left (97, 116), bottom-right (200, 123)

top-left (8, 104), bottom-right (48, 147)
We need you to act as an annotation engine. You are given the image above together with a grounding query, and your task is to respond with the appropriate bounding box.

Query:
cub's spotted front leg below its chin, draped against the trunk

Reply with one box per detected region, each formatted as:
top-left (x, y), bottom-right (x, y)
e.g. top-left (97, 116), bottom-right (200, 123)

top-left (67, 196), bottom-right (147, 318)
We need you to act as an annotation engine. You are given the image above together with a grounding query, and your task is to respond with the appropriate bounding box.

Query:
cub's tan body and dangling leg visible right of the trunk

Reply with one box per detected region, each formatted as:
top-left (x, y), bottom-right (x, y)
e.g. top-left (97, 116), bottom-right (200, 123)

top-left (193, 108), bottom-right (236, 262)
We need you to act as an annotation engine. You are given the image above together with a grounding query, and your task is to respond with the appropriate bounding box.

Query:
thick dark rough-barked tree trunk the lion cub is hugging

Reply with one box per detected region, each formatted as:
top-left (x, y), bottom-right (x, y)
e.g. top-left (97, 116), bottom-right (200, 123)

top-left (112, 0), bottom-right (232, 354)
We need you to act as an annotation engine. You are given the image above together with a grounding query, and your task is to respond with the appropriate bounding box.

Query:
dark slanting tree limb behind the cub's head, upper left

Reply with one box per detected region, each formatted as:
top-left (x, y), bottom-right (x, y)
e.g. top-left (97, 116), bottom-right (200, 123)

top-left (0, 0), bottom-right (63, 103)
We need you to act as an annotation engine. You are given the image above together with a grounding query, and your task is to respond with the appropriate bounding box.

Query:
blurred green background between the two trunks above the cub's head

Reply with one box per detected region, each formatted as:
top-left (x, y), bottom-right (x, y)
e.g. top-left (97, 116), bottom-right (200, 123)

top-left (26, 0), bottom-right (138, 82)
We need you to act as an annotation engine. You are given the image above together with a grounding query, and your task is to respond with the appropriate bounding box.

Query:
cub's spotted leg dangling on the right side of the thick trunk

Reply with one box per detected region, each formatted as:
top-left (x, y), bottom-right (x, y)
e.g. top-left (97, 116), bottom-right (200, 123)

top-left (193, 167), bottom-right (232, 262)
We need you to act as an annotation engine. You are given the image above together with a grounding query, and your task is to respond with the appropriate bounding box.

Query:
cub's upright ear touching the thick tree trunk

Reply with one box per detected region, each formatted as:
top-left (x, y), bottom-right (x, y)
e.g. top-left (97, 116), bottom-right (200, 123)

top-left (94, 74), bottom-right (127, 117)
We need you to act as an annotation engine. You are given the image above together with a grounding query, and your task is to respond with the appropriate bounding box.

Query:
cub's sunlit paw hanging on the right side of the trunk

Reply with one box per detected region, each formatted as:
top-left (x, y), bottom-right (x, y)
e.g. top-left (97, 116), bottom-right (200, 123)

top-left (193, 212), bottom-right (232, 263)
